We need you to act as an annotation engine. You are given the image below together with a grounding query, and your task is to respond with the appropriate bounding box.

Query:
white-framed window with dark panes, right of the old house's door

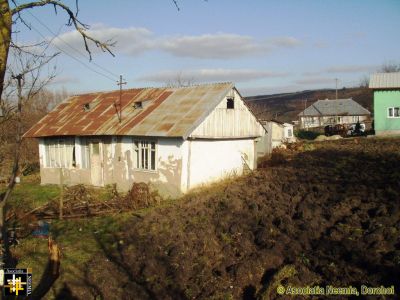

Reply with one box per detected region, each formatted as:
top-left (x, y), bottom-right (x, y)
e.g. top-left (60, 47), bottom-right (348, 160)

top-left (133, 139), bottom-right (157, 171)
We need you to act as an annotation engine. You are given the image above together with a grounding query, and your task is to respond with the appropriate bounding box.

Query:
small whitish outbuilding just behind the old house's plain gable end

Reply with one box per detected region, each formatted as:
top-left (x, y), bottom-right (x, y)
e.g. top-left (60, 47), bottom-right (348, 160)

top-left (260, 120), bottom-right (296, 152)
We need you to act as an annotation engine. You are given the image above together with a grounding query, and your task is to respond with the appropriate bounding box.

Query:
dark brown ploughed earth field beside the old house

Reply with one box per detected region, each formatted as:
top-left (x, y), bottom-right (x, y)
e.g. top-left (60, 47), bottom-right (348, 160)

top-left (74, 138), bottom-right (400, 299)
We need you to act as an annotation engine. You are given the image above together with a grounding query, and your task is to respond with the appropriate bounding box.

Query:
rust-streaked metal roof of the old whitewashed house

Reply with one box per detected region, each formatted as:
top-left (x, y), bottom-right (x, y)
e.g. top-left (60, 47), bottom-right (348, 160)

top-left (24, 83), bottom-right (233, 139)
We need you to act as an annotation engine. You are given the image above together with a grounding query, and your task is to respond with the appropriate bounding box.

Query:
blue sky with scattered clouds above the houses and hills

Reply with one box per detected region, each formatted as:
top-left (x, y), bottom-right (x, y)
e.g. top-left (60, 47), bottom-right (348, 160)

top-left (10, 0), bottom-right (400, 95)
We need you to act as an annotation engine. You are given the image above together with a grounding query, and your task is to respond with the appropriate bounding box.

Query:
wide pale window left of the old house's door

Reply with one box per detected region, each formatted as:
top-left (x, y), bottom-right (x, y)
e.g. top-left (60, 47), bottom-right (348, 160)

top-left (45, 138), bottom-right (76, 168)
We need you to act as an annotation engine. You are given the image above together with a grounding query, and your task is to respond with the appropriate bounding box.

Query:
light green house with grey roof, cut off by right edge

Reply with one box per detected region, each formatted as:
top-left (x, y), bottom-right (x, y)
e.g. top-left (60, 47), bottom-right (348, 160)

top-left (369, 72), bottom-right (400, 135)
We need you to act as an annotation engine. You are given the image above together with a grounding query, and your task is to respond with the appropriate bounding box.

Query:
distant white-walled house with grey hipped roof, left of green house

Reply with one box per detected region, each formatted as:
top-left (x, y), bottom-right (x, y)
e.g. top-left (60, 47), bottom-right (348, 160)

top-left (298, 98), bottom-right (371, 128)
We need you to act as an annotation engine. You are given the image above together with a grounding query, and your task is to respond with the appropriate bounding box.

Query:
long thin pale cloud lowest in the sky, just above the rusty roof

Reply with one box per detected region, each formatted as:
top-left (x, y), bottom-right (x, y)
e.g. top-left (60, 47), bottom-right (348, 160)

top-left (138, 69), bottom-right (288, 83)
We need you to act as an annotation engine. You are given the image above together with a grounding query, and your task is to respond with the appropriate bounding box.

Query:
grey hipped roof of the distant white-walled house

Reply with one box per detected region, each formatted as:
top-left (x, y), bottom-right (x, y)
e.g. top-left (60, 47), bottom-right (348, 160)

top-left (298, 98), bottom-right (371, 116)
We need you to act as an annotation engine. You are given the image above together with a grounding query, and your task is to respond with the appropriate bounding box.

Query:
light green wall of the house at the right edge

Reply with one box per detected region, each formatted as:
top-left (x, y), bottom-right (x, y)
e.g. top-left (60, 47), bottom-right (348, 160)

top-left (374, 90), bottom-right (400, 134)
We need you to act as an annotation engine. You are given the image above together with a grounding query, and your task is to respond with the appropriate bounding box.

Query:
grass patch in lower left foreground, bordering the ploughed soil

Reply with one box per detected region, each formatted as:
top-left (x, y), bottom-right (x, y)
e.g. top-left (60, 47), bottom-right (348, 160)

top-left (12, 212), bottom-right (139, 297)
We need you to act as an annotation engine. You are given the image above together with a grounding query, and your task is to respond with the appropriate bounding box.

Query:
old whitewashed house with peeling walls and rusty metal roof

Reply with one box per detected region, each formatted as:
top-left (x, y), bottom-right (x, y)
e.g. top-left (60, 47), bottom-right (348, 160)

top-left (24, 83), bottom-right (265, 195)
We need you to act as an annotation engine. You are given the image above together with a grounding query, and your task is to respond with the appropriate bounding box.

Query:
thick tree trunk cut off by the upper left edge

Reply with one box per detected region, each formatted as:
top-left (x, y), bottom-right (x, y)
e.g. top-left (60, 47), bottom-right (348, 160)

top-left (0, 0), bottom-right (12, 98)
